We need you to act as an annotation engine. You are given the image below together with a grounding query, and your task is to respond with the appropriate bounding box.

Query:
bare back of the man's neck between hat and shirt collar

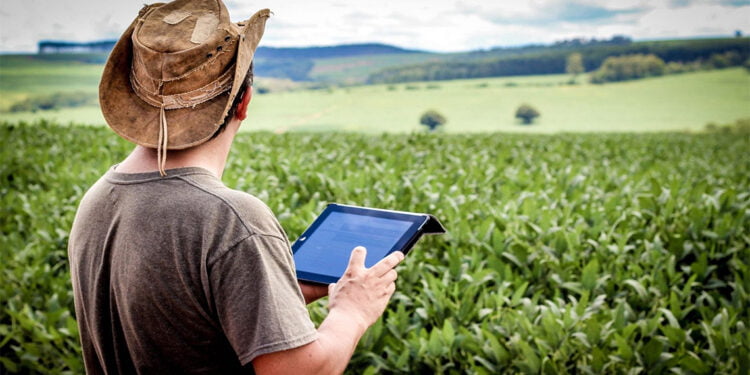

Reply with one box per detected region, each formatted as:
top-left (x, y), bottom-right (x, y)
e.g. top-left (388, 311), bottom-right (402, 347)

top-left (117, 121), bottom-right (239, 179)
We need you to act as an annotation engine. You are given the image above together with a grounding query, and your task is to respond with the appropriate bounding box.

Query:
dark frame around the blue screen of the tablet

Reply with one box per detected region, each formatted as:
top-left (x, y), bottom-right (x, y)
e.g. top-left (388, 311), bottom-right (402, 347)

top-left (292, 203), bottom-right (430, 284)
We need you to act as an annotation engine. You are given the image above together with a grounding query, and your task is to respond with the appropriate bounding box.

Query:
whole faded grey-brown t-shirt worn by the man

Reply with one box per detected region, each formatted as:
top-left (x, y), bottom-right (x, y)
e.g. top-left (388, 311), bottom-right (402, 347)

top-left (68, 168), bottom-right (317, 374)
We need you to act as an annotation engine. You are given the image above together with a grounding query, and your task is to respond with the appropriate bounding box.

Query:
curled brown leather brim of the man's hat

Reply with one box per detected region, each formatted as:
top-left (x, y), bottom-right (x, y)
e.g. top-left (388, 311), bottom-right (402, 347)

top-left (99, 4), bottom-right (270, 150)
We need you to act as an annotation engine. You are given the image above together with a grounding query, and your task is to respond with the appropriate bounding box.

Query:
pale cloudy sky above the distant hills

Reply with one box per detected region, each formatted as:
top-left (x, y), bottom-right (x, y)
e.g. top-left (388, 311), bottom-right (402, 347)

top-left (0, 0), bottom-right (750, 52)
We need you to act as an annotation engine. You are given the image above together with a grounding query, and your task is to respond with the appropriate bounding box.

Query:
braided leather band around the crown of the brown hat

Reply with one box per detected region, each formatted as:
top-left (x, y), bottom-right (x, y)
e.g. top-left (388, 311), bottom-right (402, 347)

top-left (130, 64), bottom-right (234, 109)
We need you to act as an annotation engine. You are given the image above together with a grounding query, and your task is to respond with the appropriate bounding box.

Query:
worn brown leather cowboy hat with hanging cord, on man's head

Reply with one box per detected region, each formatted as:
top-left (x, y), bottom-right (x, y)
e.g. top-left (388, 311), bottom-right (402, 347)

top-left (99, 0), bottom-right (271, 173)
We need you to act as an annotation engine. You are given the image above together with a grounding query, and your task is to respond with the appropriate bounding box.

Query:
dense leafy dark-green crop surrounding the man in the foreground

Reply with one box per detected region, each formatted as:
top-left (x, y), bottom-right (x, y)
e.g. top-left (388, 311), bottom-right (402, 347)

top-left (0, 122), bottom-right (750, 374)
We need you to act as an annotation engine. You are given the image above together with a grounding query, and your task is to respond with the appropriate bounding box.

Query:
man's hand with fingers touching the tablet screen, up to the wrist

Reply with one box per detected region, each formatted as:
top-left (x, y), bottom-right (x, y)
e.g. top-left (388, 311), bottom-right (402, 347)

top-left (328, 246), bottom-right (404, 329)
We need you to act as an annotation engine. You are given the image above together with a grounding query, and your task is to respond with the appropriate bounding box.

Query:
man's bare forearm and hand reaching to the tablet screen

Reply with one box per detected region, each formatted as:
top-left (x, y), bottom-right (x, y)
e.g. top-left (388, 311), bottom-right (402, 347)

top-left (253, 247), bottom-right (404, 375)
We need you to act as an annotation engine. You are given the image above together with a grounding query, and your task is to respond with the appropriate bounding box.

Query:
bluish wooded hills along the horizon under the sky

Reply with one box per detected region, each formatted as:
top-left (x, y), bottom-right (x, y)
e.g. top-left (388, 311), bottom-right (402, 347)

top-left (29, 36), bottom-right (750, 85)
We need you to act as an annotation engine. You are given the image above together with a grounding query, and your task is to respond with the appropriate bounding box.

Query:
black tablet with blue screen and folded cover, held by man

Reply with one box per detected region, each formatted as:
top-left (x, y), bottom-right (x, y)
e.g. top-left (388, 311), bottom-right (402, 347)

top-left (292, 203), bottom-right (445, 284)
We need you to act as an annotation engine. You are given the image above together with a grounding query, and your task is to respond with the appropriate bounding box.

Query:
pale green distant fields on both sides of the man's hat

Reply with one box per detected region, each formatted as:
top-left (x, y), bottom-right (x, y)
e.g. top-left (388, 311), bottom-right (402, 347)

top-left (0, 54), bottom-right (750, 134)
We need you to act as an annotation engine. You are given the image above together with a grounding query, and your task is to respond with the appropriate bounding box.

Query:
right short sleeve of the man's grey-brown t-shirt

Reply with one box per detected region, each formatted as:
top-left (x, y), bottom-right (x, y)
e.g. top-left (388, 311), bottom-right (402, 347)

top-left (209, 234), bottom-right (317, 365)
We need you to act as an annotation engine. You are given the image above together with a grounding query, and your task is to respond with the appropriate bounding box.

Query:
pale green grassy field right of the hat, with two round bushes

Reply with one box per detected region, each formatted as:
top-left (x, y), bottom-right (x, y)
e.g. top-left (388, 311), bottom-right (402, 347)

top-left (247, 69), bottom-right (750, 133)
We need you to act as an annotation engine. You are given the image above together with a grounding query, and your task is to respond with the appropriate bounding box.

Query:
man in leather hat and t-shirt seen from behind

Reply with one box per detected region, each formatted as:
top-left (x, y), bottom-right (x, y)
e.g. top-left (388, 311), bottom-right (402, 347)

top-left (68, 0), bottom-right (403, 374)
